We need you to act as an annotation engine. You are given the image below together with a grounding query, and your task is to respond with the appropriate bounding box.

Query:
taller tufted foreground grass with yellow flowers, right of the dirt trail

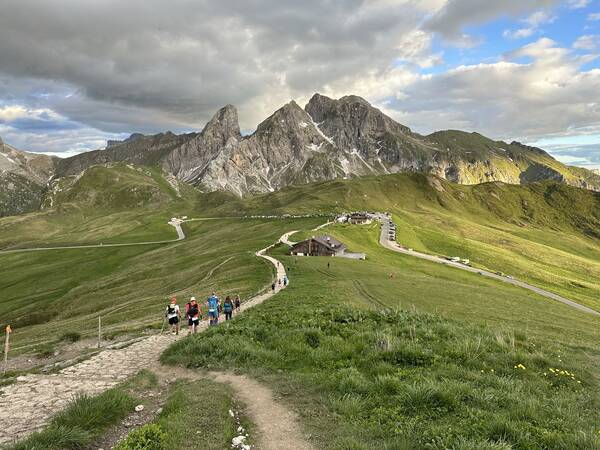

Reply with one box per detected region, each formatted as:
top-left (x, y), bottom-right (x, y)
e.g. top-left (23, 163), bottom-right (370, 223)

top-left (163, 296), bottom-right (600, 449)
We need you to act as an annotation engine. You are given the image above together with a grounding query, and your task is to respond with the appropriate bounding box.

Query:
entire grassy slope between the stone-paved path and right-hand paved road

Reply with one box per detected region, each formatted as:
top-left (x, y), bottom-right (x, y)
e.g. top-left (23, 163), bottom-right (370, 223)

top-left (163, 226), bottom-right (600, 449)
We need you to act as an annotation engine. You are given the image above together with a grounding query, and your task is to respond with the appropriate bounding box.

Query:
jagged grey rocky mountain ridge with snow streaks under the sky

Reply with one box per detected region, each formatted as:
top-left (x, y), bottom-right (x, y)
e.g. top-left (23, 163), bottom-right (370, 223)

top-left (25, 94), bottom-right (600, 196)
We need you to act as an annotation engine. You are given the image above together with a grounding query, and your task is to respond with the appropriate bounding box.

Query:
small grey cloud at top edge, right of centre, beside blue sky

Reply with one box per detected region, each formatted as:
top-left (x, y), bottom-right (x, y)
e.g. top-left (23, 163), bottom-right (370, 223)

top-left (424, 0), bottom-right (556, 44)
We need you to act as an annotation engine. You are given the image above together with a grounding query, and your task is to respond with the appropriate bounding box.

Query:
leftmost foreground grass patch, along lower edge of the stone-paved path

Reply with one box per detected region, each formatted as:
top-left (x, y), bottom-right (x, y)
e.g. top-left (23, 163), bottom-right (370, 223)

top-left (9, 372), bottom-right (156, 450)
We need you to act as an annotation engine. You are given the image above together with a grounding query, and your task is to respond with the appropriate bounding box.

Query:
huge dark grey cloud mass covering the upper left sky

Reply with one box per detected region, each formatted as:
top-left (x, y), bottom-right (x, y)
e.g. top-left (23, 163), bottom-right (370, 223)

top-left (0, 0), bottom-right (439, 132)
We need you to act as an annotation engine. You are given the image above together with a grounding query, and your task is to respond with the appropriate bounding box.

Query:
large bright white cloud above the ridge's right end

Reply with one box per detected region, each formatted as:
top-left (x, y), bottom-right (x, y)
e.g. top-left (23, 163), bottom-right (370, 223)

top-left (386, 38), bottom-right (600, 150)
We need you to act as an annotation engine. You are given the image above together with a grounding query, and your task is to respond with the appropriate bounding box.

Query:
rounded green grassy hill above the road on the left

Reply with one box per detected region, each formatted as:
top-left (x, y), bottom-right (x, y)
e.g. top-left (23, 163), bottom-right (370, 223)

top-left (0, 165), bottom-right (198, 249)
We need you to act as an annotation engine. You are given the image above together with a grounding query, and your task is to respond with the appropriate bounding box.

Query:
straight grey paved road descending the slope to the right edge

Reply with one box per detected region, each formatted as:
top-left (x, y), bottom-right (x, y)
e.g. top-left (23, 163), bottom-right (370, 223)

top-left (378, 215), bottom-right (600, 317)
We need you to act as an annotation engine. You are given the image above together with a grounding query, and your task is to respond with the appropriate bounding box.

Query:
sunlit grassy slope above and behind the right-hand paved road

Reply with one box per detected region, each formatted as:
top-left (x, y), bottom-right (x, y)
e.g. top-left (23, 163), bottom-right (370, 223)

top-left (198, 174), bottom-right (600, 309)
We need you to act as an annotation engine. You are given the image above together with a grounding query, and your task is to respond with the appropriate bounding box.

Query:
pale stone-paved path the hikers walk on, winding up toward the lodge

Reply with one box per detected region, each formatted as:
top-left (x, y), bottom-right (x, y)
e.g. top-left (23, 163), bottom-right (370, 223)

top-left (0, 232), bottom-right (286, 446)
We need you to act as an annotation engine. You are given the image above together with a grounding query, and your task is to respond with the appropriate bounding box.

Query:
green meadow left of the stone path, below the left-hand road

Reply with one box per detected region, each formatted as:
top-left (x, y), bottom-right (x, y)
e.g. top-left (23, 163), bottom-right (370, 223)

top-left (0, 219), bottom-right (320, 351)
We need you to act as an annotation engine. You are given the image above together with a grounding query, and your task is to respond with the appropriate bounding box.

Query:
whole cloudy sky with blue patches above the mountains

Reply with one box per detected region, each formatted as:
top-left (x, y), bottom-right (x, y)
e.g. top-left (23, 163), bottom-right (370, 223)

top-left (0, 0), bottom-right (600, 168)
